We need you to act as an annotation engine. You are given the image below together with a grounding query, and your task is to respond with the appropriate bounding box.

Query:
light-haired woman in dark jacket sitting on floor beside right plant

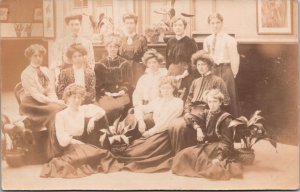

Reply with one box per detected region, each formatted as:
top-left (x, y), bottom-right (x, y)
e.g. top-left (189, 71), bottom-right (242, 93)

top-left (172, 89), bottom-right (242, 180)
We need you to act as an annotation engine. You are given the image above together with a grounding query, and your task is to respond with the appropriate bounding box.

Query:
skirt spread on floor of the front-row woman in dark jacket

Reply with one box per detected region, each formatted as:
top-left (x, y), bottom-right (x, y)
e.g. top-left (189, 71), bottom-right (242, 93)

top-left (172, 143), bottom-right (243, 180)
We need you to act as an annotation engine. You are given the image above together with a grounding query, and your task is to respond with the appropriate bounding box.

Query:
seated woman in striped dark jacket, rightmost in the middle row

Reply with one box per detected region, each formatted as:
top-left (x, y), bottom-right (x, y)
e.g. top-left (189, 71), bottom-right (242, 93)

top-left (169, 50), bottom-right (230, 153)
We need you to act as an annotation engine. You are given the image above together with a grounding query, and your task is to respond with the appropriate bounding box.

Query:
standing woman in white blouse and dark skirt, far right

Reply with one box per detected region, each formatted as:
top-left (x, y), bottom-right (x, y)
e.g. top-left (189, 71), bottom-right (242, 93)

top-left (203, 13), bottom-right (240, 117)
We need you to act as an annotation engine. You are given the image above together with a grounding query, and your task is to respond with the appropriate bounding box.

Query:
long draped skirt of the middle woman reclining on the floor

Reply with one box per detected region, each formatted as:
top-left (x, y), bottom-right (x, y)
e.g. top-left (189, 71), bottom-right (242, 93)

top-left (117, 131), bottom-right (173, 173)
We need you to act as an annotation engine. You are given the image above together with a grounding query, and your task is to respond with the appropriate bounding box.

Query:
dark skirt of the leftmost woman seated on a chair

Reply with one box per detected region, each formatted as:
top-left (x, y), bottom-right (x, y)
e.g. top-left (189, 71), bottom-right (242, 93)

top-left (20, 96), bottom-right (65, 131)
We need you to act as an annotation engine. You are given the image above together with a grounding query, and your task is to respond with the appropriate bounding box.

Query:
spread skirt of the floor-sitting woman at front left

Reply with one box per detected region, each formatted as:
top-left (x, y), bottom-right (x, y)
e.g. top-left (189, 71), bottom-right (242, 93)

top-left (40, 144), bottom-right (123, 178)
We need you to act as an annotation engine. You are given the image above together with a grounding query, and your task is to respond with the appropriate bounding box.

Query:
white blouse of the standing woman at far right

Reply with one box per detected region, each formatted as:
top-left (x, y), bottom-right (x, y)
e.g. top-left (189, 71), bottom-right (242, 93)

top-left (203, 32), bottom-right (240, 76)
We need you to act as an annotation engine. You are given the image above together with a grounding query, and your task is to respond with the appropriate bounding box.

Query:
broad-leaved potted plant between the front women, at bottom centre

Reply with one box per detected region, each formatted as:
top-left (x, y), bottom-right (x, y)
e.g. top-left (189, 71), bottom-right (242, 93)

top-left (100, 110), bottom-right (138, 154)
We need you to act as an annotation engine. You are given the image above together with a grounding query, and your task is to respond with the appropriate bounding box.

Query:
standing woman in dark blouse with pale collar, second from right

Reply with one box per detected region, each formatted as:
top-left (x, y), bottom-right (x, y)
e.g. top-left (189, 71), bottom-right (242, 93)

top-left (166, 17), bottom-right (199, 101)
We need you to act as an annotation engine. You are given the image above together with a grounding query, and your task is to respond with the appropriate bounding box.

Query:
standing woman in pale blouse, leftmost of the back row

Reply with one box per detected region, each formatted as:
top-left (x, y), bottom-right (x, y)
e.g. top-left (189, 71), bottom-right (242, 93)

top-left (50, 14), bottom-right (95, 72)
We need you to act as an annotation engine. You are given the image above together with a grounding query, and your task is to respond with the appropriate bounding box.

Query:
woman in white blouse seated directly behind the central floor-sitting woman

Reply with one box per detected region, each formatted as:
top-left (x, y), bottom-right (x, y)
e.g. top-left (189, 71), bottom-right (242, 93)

top-left (132, 49), bottom-right (168, 107)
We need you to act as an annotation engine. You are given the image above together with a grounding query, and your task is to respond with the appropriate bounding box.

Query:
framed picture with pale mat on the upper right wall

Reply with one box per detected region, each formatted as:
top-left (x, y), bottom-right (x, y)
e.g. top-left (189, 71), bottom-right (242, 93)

top-left (256, 0), bottom-right (292, 34)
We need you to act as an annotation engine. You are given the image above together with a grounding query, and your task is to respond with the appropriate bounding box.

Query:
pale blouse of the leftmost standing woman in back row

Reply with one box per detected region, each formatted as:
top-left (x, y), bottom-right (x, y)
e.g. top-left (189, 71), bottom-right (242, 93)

top-left (49, 35), bottom-right (95, 69)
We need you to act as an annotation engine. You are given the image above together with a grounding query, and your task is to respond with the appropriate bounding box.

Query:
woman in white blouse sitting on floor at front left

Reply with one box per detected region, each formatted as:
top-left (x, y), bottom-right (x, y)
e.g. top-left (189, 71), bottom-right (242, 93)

top-left (41, 84), bottom-right (122, 178)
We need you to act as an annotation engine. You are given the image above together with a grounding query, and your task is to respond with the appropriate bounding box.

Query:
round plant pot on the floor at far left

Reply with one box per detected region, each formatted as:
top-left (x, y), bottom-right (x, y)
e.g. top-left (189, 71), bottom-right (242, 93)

top-left (6, 149), bottom-right (25, 167)
